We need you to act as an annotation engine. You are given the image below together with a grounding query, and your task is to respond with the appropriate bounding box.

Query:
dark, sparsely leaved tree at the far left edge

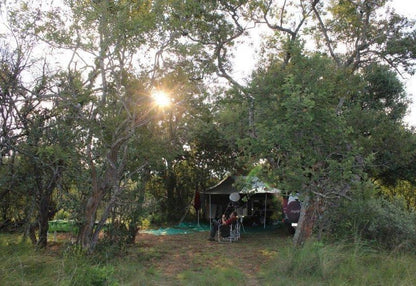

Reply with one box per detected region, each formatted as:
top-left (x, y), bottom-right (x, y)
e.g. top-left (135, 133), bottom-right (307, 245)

top-left (1, 40), bottom-right (69, 247)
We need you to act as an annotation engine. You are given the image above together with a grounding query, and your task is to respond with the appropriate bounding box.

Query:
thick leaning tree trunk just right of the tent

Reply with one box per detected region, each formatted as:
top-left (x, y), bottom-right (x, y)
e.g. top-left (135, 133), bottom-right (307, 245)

top-left (293, 195), bottom-right (316, 246)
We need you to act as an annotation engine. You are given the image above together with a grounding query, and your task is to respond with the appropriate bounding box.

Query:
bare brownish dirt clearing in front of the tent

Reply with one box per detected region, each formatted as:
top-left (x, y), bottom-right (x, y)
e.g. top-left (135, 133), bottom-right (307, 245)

top-left (137, 230), bottom-right (290, 285)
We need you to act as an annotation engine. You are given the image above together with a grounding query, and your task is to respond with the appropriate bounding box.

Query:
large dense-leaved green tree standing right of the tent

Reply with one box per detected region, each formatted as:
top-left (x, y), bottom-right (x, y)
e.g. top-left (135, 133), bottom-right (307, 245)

top-left (240, 0), bottom-right (415, 244)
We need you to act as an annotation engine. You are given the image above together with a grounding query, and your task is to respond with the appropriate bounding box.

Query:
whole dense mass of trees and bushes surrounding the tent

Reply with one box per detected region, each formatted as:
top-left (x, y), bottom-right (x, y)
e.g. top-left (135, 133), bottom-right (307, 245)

top-left (0, 0), bottom-right (416, 260)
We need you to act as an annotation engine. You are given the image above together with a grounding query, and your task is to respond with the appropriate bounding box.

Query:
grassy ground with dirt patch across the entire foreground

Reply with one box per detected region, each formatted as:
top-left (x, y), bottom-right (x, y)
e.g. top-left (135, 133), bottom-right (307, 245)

top-left (0, 230), bottom-right (416, 286)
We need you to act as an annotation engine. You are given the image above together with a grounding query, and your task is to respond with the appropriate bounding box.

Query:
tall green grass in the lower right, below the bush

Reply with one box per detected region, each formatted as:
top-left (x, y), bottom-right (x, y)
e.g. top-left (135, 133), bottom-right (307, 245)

top-left (261, 242), bottom-right (416, 286)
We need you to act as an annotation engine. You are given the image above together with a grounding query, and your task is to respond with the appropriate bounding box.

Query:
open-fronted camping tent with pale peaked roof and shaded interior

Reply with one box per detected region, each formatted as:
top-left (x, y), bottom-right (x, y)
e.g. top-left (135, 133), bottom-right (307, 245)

top-left (202, 176), bottom-right (281, 227)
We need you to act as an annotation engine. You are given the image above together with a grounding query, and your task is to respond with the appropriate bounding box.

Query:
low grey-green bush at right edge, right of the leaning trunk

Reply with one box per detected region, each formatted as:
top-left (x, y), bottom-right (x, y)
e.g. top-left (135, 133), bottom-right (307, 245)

top-left (326, 198), bottom-right (416, 251)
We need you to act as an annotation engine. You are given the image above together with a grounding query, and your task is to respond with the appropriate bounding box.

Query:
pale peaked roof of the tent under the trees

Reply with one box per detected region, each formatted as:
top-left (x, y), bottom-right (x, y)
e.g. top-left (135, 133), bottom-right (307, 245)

top-left (203, 176), bottom-right (281, 195)
